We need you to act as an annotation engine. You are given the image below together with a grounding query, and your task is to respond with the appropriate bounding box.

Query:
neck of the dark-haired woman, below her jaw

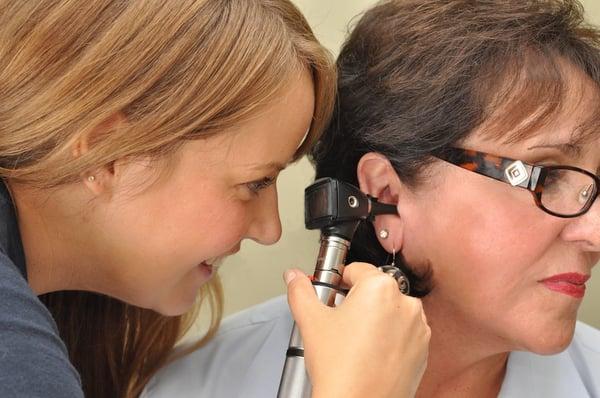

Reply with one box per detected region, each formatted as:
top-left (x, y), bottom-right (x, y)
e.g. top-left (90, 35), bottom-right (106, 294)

top-left (416, 297), bottom-right (508, 398)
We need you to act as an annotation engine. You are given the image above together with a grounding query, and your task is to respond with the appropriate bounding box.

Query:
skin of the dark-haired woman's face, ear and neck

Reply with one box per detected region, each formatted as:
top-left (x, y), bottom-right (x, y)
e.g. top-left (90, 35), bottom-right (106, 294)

top-left (358, 63), bottom-right (600, 397)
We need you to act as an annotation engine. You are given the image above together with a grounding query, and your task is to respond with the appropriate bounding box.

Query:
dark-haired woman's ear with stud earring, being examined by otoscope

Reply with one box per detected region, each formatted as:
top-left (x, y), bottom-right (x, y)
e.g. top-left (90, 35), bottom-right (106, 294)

top-left (356, 152), bottom-right (407, 253)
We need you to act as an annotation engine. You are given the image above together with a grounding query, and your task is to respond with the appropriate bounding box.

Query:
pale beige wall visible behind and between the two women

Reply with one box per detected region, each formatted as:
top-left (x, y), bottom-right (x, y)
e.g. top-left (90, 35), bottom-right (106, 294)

top-left (220, 0), bottom-right (600, 328)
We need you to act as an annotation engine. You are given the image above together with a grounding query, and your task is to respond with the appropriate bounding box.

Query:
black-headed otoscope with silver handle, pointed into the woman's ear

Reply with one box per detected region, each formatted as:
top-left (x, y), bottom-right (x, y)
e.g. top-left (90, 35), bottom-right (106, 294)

top-left (277, 178), bottom-right (398, 398)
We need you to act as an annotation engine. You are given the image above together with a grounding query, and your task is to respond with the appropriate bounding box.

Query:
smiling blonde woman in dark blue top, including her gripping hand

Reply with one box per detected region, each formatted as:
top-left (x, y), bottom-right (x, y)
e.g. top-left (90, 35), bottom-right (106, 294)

top-left (0, 0), bottom-right (429, 398)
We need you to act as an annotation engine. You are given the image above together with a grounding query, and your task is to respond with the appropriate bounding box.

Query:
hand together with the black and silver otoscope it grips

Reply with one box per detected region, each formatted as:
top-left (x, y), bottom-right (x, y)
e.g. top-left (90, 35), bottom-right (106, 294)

top-left (278, 179), bottom-right (429, 398)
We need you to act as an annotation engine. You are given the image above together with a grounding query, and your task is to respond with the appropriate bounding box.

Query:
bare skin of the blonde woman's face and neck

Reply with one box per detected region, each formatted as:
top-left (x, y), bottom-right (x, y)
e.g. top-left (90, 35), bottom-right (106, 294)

top-left (11, 71), bottom-right (314, 315)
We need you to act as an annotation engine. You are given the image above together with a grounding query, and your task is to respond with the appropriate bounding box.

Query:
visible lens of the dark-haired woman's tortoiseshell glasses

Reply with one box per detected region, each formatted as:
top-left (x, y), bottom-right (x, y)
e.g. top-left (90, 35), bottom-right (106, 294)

top-left (541, 169), bottom-right (598, 216)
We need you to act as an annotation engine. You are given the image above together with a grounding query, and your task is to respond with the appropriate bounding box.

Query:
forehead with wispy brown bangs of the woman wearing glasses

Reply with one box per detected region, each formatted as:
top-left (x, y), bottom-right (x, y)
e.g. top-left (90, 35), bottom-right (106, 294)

top-left (467, 58), bottom-right (600, 149)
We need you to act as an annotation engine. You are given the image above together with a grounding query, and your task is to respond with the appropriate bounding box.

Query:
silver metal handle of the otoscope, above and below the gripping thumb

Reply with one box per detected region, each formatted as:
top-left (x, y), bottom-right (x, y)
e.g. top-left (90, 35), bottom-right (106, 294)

top-left (277, 235), bottom-right (350, 398)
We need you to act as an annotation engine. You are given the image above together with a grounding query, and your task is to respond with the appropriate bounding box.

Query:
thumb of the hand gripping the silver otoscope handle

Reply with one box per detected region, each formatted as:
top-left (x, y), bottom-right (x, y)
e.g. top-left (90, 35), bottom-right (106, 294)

top-left (283, 269), bottom-right (322, 328)
